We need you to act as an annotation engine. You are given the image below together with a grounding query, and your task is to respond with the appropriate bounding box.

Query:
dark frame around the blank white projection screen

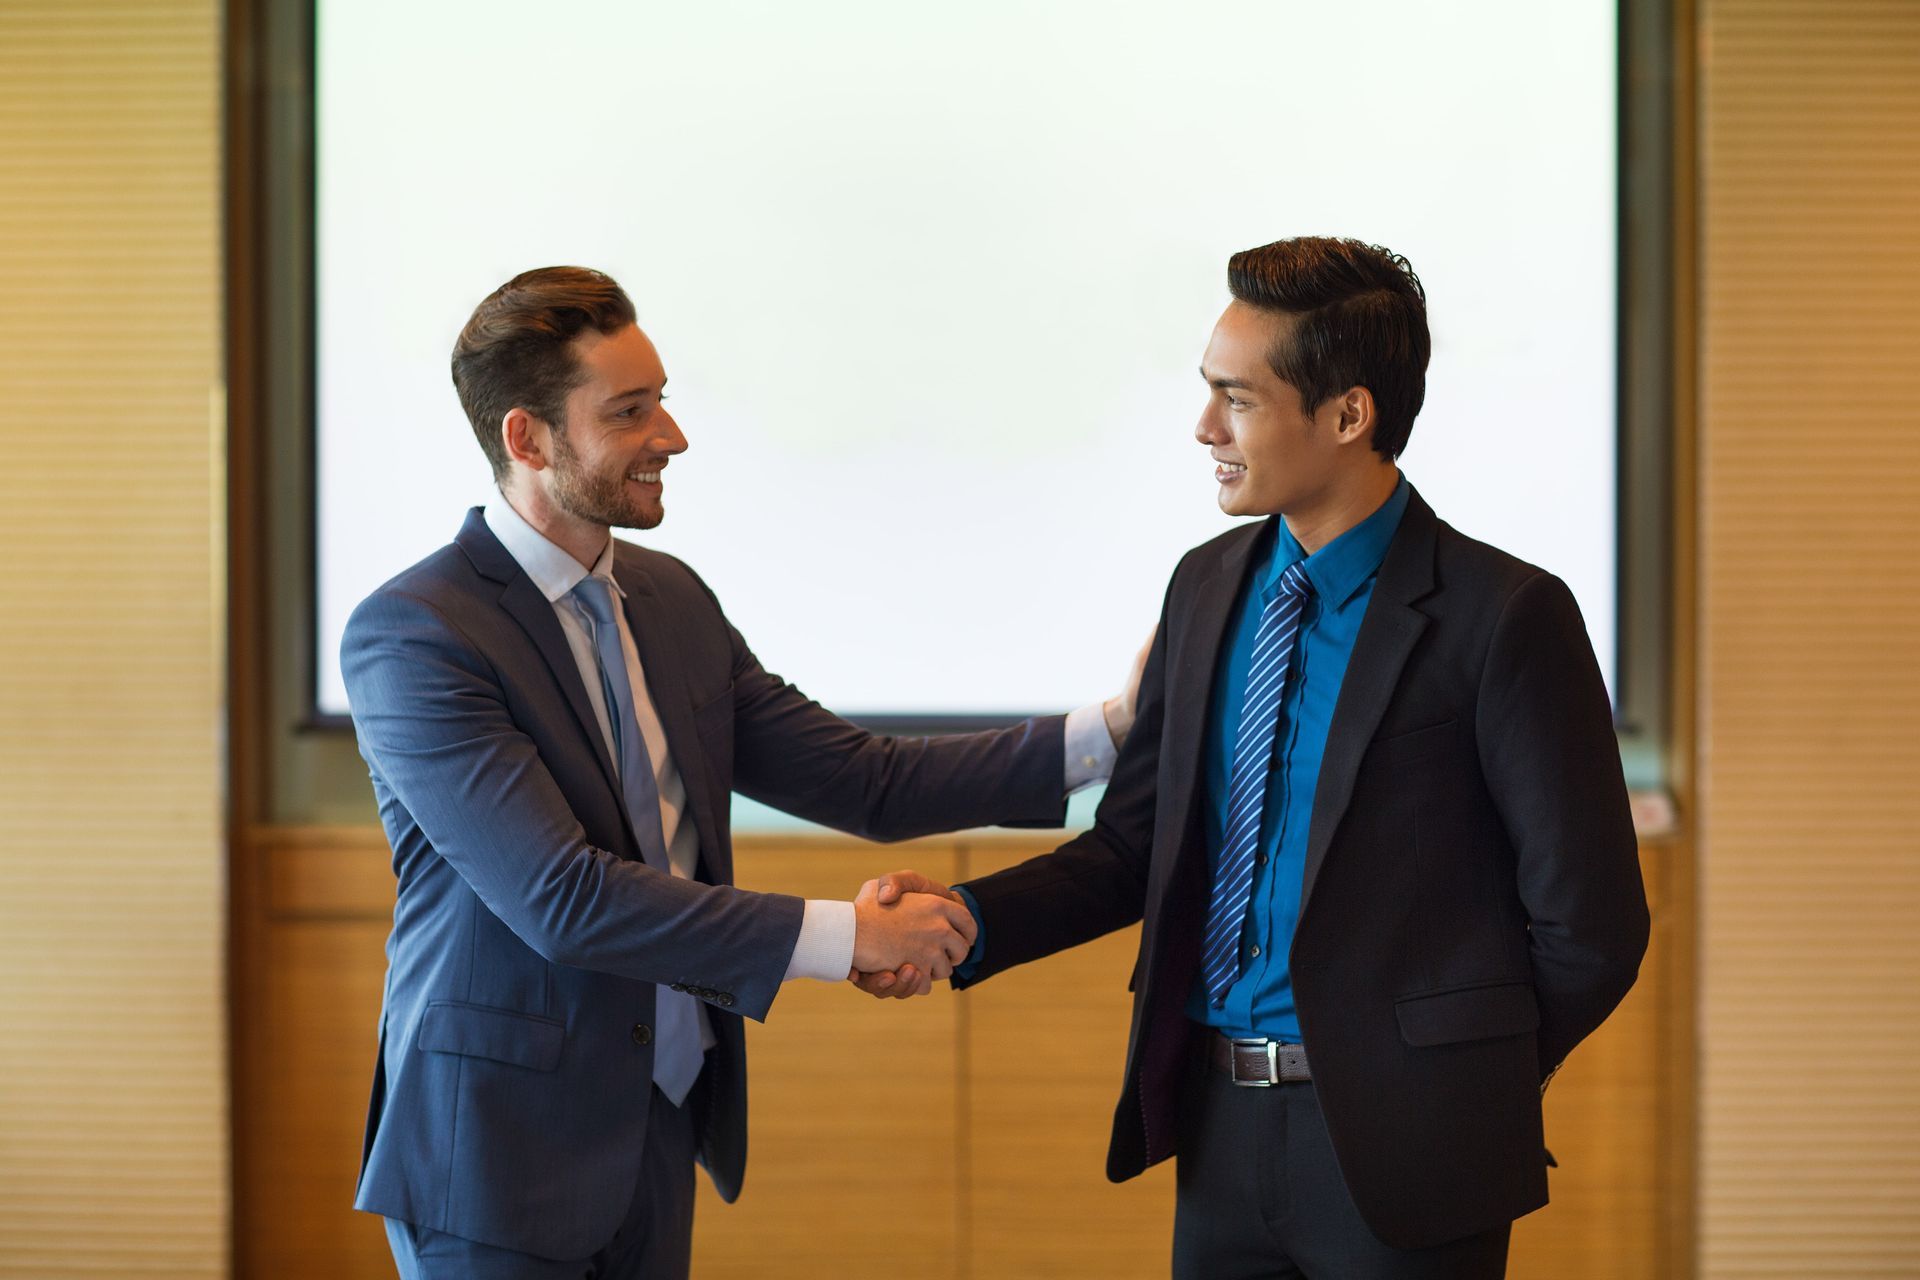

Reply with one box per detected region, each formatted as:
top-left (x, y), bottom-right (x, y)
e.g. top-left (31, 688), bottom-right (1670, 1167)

top-left (228, 0), bottom-right (1680, 808)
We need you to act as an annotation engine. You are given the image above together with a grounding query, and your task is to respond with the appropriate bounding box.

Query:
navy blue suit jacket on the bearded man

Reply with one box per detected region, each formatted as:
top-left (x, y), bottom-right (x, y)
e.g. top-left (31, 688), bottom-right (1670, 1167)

top-left (340, 509), bottom-right (1066, 1257)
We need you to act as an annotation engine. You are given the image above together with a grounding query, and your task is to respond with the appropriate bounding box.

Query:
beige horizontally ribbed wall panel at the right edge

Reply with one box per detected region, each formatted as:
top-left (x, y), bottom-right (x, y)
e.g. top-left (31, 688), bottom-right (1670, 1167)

top-left (1699, 0), bottom-right (1920, 1278)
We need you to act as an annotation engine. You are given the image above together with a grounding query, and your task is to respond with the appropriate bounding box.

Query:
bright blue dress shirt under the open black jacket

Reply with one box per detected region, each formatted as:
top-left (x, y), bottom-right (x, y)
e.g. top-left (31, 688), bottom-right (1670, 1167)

top-left (1187, 478), bottom-right (1409, 1044)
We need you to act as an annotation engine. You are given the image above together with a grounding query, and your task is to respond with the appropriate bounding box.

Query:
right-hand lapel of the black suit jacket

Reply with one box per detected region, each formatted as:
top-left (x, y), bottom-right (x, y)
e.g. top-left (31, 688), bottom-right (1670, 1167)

top-left (1300, 493), bottom-right (1438, 915)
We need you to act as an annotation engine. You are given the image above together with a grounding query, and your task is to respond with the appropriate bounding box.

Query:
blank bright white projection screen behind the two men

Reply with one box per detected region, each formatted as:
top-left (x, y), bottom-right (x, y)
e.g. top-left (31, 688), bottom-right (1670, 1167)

top-left (315, 0), bottom-right (1617, 720)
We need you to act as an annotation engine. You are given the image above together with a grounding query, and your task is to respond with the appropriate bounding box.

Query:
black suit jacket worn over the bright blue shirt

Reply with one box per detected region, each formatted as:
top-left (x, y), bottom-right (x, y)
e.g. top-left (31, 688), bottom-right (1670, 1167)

top-left (956, 493), bottom-right (1647, 1247)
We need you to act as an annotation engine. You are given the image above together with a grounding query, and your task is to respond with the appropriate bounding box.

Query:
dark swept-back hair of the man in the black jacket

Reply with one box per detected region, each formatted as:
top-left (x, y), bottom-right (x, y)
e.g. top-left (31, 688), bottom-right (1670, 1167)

top-left (1227, 236), bottom-right (1432, 461)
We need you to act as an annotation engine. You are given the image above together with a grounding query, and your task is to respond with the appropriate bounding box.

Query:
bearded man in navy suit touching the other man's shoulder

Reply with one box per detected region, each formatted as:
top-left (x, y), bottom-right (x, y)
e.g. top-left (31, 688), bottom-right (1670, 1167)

top-left (340, 267), bottom-right (1131, 1280)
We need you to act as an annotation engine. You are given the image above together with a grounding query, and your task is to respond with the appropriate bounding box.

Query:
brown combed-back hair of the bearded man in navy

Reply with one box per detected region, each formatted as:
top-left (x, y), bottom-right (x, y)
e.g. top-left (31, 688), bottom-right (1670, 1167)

top-left (453, 267), bottom-right (634, 484)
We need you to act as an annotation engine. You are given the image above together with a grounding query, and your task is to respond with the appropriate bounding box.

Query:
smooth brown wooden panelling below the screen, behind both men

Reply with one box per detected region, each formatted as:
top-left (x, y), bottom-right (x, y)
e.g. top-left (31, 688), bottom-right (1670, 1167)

top-left (242, 827), bottom-right (1684, 1280)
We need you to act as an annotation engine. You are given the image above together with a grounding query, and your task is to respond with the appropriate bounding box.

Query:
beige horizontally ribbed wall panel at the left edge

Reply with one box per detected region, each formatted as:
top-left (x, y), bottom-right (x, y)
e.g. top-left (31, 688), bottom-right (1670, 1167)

top-left (0, 0), bottom-right (227, 1278)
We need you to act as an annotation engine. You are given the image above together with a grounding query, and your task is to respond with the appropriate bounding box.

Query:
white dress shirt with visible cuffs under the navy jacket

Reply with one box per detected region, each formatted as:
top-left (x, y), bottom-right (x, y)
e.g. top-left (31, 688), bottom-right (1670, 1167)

top-left (486, 501), bottom-right (1117, 990)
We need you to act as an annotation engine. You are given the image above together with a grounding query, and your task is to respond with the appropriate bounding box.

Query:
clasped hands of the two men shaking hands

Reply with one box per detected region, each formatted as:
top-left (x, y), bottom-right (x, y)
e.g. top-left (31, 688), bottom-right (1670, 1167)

top-left (847, 871), bottom-right (979, 1000)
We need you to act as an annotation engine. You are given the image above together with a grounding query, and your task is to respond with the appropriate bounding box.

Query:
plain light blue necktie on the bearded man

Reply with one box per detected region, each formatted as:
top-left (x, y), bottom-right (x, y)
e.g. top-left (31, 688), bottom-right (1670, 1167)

top-left (572, 576), bottom-right (703, 1107)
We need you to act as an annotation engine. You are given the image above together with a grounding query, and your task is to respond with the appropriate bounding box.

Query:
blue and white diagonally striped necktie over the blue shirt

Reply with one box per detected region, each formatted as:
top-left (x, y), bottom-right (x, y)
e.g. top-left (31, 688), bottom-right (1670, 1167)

top-left (1200, 560), bottom-right (1313, 1006)
